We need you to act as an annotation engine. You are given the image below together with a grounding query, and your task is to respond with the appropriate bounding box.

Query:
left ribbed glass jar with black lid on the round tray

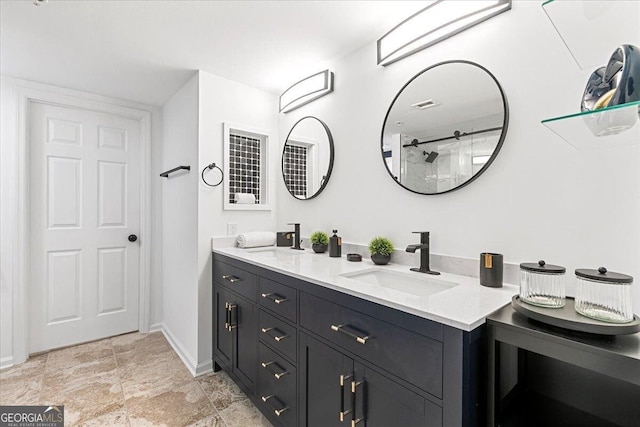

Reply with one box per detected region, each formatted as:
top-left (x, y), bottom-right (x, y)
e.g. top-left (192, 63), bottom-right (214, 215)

top-left (520, 260), bottom-right (567, 308)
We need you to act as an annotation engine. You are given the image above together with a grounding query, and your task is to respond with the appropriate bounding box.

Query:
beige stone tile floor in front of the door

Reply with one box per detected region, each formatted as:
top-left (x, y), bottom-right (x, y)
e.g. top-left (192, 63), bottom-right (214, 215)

top-left (0, 332), bottom-right (271, 427)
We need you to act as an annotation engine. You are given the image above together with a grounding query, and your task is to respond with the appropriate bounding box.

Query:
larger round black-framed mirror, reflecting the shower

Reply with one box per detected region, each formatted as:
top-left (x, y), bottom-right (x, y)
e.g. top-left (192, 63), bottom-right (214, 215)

top-left (381, 60), bottom-right (509, 194)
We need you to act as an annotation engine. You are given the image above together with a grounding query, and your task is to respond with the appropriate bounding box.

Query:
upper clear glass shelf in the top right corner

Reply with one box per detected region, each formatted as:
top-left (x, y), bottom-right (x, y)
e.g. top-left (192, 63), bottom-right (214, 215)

top-left (542, 0), bottom-right (640, 71)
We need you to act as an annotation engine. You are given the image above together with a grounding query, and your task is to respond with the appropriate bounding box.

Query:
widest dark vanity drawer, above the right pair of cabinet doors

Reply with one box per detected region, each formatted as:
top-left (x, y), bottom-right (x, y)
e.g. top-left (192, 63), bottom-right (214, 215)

top-left (300, 292), bottom-right (442, 398)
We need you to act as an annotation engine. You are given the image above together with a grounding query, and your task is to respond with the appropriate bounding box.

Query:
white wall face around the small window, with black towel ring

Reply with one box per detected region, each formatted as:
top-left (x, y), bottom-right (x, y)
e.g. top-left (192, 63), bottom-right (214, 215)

top-left (196, 71), bottom-right (281, 369)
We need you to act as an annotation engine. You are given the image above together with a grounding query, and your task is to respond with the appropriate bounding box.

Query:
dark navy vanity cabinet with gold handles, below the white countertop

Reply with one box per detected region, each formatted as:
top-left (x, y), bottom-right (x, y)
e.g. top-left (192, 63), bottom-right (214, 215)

top-left (213, 253), bottom-right (486, 427)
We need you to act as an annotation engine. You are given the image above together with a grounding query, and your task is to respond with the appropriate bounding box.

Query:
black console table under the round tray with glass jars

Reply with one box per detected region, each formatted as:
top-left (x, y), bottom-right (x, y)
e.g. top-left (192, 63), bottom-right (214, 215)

top-left (487, 306), bottom-right (640, 426)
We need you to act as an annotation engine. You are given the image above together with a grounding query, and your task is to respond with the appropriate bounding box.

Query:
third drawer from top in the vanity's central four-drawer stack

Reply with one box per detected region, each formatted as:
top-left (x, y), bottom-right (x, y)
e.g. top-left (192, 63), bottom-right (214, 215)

top-left (258, 343), bottom-right (297, 406)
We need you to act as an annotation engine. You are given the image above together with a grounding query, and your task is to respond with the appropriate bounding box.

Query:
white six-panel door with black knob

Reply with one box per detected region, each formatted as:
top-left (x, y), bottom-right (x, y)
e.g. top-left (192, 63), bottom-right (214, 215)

top-left (29, 102), bottom-right (140, 353)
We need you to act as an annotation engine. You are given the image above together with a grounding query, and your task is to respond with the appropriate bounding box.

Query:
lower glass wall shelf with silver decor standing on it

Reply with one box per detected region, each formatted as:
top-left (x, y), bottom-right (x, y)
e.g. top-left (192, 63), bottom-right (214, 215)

top-left (542, 101), bottom-right (640, 150)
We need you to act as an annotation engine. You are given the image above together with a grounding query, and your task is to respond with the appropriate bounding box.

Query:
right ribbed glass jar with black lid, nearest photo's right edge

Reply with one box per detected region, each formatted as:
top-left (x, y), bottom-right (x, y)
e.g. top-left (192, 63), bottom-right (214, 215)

top-left (576, 267), bottom-right (633, 323)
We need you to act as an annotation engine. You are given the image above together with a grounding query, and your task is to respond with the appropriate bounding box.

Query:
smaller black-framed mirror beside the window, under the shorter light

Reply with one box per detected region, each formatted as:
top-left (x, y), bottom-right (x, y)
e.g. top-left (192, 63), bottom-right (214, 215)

top-left (282, 116), bottom-right (333, 200)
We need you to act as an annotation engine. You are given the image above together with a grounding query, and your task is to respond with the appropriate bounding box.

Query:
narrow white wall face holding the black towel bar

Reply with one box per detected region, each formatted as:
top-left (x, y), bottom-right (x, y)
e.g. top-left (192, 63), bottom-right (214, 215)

top-left (160, 73), bottom-right (199, 369)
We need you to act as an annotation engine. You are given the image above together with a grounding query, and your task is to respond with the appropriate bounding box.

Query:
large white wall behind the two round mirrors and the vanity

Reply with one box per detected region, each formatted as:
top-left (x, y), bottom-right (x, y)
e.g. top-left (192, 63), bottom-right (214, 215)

top-left (277, 1), bottom-right (640, 312)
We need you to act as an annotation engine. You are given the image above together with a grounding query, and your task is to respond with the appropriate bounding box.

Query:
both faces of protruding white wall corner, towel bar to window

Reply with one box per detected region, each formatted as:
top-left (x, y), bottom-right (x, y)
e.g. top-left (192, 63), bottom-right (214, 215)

top-left (158, 71), bottom-right (279, 374)
